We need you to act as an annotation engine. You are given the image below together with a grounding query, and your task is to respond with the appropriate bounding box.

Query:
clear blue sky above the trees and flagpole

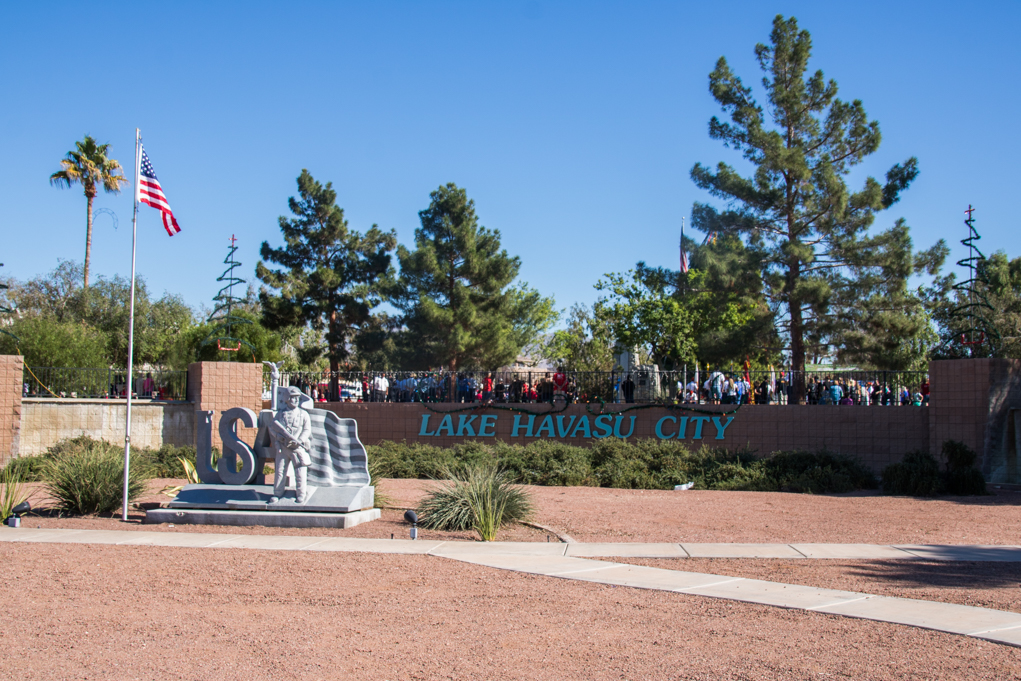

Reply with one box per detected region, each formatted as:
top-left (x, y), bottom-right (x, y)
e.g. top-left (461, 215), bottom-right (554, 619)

top-left (0, 1), bottom-right (1021, 320)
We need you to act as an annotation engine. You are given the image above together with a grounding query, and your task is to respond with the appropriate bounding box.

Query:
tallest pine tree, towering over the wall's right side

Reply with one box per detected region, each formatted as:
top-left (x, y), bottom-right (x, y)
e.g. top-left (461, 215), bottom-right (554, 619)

top-left (691, 15), bottom-right (945, 396)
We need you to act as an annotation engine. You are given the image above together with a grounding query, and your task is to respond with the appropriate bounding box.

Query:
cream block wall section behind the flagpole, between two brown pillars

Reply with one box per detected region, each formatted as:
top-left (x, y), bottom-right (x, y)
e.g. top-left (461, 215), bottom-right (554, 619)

top-left (18, 398), bottom-right (195, 456)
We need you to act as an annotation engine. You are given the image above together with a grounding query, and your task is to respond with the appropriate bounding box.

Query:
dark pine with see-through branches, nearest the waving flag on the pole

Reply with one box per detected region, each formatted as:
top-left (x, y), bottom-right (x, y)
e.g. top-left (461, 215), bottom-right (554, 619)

top-left (255, 169), bottom-right (397, 397)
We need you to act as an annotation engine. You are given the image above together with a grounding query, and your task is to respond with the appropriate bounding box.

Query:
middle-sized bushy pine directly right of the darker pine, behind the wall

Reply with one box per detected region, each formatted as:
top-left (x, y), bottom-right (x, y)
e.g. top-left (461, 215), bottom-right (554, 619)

top-left (394, 183), bottom-right (555, 372)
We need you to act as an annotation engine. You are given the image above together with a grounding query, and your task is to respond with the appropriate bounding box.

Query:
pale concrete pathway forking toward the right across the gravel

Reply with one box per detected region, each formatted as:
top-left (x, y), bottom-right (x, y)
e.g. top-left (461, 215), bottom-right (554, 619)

top-left (0, 528), bottom-right (1021, 647)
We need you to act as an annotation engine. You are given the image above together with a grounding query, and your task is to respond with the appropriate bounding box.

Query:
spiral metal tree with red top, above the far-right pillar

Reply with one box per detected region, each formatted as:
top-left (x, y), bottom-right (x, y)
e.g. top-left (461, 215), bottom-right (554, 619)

top-left (951, 205), bottom-right (1000, 357)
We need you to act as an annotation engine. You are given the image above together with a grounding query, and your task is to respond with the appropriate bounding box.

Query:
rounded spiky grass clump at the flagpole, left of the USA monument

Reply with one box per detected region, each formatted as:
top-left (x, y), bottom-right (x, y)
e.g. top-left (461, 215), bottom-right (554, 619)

top-left (44, 441), bottom-right (150, 516)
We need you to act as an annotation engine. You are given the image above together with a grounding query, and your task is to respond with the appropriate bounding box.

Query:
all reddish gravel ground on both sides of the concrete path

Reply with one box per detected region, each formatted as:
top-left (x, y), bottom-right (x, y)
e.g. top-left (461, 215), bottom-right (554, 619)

top-left (0, 480), bottom-right (1021, 680)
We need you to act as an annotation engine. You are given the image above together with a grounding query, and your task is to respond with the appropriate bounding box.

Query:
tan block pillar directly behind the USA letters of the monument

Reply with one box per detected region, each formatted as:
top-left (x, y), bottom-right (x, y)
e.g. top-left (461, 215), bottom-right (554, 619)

top-left (188, 361), bottom-right (262, 447)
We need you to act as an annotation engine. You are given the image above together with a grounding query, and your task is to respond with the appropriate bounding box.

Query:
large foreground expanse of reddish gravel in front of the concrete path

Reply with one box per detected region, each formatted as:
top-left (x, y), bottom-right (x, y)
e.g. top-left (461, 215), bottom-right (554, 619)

top-left (0, 544), bottom-right (1021, 680)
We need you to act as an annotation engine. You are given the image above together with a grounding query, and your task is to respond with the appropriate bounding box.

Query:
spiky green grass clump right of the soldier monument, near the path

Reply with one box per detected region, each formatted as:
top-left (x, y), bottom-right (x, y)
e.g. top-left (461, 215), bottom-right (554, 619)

top-left (419, 464), bottom-right (533, 541)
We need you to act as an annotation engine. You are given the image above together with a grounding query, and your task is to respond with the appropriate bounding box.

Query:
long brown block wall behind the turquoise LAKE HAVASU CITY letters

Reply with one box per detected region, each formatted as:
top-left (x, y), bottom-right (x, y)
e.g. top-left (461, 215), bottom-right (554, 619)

top-left (320, 402), bottom-right (929, 472)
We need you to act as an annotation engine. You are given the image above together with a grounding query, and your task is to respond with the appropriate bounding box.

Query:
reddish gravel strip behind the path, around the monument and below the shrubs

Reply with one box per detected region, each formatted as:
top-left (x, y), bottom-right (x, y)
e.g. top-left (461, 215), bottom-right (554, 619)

top-left (13, 480), bottom-right (1021, 544)
